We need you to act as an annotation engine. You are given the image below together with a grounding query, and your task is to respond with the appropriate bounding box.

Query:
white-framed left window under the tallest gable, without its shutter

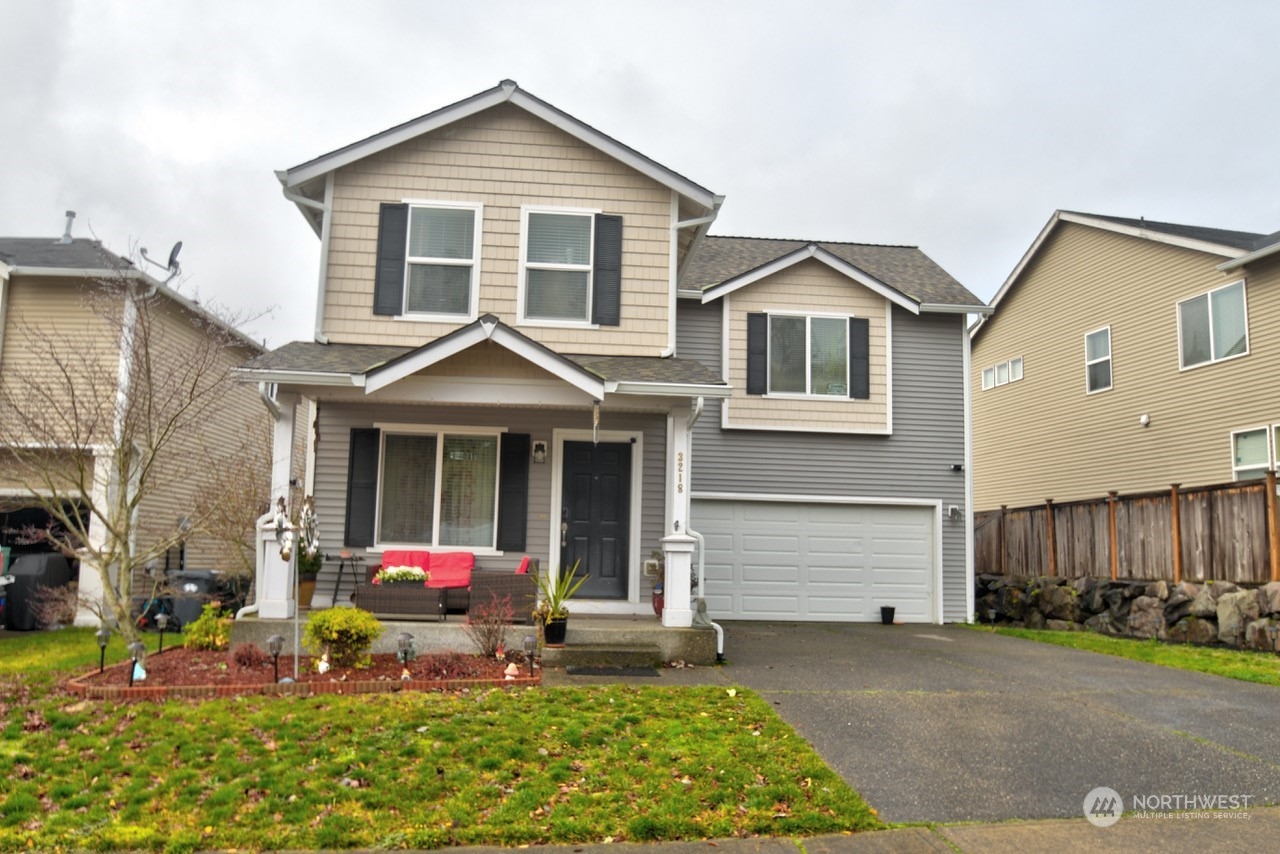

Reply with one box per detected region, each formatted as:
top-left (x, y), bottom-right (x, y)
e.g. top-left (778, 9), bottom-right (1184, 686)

top-left (404, 205), bottom-right (479, 316)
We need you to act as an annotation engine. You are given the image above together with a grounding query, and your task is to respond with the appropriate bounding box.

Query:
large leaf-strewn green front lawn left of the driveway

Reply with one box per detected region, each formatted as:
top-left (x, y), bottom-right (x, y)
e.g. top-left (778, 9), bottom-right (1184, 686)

top-left (0, 631), bottom-right (882, 851)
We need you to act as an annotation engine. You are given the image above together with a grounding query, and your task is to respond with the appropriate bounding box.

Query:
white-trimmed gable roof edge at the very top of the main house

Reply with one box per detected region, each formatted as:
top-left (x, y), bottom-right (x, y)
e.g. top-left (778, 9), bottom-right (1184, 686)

top-left (275, 79), bottom-right (721, 230)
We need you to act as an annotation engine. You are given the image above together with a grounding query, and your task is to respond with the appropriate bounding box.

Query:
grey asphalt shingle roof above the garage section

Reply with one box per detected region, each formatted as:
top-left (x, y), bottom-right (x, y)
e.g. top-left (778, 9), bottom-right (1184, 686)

top-left (682, 237), bottom-right (984, 306)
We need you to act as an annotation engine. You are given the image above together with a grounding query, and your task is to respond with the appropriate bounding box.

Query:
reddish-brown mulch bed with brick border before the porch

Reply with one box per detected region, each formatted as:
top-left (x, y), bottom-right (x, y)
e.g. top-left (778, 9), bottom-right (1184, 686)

top-left (68, 647), bottom-right (541, 699)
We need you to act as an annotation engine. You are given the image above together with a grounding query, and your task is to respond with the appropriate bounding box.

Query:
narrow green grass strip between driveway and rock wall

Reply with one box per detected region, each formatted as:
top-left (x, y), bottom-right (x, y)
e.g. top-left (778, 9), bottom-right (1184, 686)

top-left (974, 626), bottom-right (1280, 685)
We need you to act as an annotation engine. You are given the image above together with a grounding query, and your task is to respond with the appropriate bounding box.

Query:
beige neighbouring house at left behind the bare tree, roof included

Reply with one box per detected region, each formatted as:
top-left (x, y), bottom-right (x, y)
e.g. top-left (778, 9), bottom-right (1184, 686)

top-left (0, 224), bottom-right (269, 625)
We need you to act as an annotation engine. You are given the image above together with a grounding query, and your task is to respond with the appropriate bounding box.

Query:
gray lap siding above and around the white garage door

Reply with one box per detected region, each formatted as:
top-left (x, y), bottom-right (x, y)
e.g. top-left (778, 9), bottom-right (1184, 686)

top-left (677, 301), bottom-right (968, 621)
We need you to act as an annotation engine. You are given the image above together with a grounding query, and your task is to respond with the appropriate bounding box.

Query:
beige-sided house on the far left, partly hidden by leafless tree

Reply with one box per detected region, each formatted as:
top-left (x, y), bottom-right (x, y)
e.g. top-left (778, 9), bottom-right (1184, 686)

top-left (0, 230), bottom-right (270, 625)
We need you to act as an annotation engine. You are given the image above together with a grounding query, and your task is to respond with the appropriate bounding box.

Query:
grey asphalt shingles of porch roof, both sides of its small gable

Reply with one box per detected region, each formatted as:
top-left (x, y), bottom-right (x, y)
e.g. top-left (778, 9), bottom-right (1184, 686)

top-left (241, 341), bottom-right (723, 385)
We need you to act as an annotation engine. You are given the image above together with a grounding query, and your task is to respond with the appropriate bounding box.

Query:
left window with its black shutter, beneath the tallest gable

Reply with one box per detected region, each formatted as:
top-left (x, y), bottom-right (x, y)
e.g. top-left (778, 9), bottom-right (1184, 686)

top-left (374, 202), bottom-right (483, 321)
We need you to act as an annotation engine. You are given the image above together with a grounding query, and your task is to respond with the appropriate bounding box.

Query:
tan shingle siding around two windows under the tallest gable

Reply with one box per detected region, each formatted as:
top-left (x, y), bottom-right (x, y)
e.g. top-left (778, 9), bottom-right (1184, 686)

top-left (325, 105), bottom-right (671, 356)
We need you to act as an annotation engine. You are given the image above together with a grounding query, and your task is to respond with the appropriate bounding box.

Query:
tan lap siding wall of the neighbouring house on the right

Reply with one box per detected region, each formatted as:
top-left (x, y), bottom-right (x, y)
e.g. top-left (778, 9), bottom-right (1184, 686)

top-left (970, 224), bottom-right (1280, 510)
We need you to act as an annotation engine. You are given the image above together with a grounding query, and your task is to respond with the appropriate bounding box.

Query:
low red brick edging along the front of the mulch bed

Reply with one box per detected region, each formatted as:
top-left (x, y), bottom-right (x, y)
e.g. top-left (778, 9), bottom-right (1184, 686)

top-left (67, 661), bottom-right (543, 700)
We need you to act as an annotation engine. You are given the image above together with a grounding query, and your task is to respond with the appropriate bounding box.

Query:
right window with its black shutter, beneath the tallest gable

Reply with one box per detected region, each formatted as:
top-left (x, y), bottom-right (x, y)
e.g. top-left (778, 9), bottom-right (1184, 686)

top-left (520, 209), bottom-right (622, 325)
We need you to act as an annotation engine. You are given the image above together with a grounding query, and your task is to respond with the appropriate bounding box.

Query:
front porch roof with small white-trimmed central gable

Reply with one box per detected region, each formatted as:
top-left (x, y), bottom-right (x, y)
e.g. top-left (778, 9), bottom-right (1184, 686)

top-left (238, 315), bottom-right (730, 399)
